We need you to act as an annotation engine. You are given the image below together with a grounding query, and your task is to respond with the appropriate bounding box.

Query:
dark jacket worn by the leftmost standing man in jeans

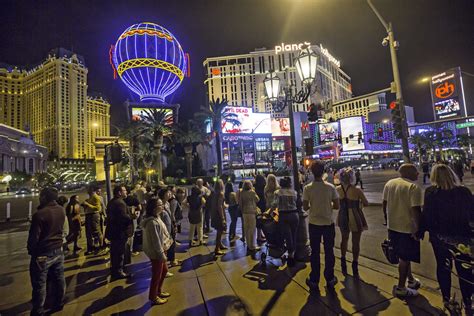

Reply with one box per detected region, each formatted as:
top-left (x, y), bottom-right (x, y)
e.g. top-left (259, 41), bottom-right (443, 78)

top-left (27, 201), bottom-right (66, 256)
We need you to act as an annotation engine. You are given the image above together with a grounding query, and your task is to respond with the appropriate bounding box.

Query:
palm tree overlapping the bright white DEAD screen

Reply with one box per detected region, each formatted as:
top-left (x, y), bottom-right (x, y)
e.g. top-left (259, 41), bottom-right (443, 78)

top-left (199, 98), bottom-right (241, 176)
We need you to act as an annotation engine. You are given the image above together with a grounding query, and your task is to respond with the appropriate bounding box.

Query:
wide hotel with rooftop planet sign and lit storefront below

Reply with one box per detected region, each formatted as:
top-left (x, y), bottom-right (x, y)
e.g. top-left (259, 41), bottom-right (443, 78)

top-left (203, 42), bottom-right (360, 173)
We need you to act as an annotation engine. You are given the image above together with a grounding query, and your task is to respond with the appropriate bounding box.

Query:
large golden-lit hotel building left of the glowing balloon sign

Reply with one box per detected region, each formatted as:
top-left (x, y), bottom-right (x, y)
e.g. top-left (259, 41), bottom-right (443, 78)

top-left (0, 48), bottom-right (110, 159)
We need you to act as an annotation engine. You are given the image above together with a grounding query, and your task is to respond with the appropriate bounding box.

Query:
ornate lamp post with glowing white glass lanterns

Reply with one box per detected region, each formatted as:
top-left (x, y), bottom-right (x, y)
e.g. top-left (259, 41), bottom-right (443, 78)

top-left (263, 47), bottom-right (317, 192)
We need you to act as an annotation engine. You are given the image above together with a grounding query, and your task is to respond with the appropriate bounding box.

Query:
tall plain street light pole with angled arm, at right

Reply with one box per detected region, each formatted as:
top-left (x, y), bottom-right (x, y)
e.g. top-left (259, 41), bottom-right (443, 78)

top-left (367, 0), bottom-right (410, 162)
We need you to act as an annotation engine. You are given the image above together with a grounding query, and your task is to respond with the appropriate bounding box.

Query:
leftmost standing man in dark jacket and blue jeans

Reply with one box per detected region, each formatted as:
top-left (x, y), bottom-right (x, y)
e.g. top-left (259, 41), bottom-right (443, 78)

top-left (27, 188), bottom-right (66, 315)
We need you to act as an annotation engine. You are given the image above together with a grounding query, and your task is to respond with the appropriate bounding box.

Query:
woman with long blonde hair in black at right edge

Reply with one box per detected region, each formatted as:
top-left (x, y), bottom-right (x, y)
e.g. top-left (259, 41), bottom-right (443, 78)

top-left (418, 164), bottom-right (474, 315)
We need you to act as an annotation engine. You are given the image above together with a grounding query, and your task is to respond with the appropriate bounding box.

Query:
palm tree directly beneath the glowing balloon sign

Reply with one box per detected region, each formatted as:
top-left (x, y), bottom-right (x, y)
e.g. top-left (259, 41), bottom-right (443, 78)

top-left (139, 109), bottom-right (171, 180)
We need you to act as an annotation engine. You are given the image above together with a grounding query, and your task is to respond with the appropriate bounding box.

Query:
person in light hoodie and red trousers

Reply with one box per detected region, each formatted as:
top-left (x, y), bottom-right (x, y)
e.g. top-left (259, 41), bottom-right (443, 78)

top-left (141, 198), bottom-right (173, 305)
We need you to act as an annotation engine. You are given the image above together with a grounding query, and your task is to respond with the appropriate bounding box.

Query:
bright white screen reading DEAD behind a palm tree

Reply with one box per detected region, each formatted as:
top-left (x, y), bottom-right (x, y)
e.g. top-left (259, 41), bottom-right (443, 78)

top-left (221, 107), bottom-right (272, 134)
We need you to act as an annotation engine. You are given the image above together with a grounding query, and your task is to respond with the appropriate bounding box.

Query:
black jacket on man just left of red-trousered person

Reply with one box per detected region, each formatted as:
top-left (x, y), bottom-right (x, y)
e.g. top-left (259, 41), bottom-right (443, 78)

top-left (105, 197), bottom-right (133, 240)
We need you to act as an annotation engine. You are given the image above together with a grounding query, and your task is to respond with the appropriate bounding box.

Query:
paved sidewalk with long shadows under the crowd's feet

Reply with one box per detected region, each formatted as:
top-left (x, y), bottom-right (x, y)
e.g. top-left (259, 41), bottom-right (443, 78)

top-left (0, 223), bottom-right (448, 316)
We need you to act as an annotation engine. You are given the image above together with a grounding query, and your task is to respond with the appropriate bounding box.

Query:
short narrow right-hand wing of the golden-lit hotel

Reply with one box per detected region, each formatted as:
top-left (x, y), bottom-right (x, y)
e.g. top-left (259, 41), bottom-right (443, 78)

top-left (86, 95), bottom-right (110, 158)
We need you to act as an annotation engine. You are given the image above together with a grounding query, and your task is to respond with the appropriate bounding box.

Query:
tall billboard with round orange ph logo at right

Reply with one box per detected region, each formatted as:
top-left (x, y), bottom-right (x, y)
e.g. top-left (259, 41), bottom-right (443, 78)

top-left (430, 67), bottom-right (465, 120)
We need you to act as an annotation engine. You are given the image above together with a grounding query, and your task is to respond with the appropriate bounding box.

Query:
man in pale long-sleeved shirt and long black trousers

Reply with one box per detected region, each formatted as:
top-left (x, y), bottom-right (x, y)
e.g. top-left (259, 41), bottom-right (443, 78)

top-left (303, 160), bottom-right (339, 291)
